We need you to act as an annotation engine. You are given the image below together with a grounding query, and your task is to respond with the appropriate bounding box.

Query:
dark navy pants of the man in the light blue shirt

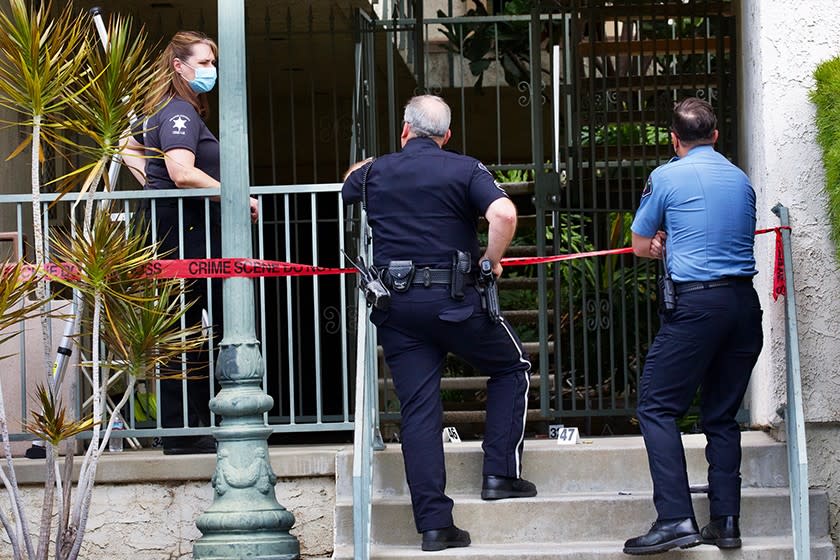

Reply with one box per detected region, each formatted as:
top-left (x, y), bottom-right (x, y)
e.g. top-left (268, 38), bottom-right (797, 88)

top-left (637, 280), bottom-right (763, 520)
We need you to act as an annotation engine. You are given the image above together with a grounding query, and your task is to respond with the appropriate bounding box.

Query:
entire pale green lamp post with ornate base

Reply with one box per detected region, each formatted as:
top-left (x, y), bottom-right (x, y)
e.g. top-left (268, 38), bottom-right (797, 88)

top-left (193, 0), bottom-right (300, 560)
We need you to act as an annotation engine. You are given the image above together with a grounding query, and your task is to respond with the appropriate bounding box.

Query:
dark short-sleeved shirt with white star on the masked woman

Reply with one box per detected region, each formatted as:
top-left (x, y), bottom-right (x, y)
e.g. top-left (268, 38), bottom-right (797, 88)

top-left (138, 97), bottom-right (221, 190)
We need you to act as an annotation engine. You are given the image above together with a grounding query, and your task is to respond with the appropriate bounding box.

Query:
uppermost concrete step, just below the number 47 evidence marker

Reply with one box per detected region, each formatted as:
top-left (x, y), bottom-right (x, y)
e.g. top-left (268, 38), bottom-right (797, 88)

top-left (336, 431), bottom-right (788, 498)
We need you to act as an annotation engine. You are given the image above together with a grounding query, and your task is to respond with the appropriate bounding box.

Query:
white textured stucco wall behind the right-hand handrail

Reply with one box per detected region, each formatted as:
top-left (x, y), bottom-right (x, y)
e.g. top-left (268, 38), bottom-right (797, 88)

top-left (739, 0), bottom-right (840, 425)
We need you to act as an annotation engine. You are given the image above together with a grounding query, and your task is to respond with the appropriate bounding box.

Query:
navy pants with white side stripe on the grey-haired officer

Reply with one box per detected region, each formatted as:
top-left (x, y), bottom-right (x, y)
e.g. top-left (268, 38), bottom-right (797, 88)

top-left (371, 286), bottom-right (531, 532)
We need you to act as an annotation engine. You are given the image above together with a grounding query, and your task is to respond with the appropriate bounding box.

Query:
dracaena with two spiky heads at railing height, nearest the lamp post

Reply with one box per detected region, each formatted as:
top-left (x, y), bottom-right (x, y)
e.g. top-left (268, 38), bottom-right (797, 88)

top-left (47, 207), bottom-right (206, 558)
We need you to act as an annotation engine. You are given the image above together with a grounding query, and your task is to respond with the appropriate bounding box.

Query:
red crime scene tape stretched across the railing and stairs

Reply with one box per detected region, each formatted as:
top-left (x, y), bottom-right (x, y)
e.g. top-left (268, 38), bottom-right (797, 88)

top-left (6, 226), bottom-right (790, 300)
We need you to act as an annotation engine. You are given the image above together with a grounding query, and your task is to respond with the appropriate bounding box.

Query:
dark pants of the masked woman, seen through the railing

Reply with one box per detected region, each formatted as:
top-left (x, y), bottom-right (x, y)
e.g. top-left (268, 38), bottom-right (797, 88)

top-left (145, 198), bottom-right (222, 428)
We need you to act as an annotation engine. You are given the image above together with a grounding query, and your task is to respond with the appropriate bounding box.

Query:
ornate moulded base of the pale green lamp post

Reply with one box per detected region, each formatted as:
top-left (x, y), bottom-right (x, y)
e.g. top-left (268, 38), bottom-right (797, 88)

top-left (193, 341), bottom-right (300, 560)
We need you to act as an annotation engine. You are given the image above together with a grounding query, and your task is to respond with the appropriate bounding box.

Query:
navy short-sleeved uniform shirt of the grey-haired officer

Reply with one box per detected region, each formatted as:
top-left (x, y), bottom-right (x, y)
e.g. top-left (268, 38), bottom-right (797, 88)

top-left (341, 138), bottom-right (507, 267)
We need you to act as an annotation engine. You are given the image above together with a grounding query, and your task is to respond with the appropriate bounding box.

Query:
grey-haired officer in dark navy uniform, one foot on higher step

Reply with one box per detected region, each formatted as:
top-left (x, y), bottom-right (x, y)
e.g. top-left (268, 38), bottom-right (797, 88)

top-left (342, 95), bottom-right (537, 550)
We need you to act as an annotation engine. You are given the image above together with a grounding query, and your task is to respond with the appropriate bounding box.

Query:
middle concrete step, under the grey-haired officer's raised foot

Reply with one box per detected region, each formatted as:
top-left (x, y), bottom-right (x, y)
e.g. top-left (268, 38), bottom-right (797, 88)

top-left (335, 488), bottom-right (829, 545)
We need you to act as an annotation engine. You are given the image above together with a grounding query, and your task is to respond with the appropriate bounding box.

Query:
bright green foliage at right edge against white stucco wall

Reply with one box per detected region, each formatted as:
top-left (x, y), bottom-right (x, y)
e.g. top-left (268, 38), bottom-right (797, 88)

top-left (811, 57), bottom-right (840, 257)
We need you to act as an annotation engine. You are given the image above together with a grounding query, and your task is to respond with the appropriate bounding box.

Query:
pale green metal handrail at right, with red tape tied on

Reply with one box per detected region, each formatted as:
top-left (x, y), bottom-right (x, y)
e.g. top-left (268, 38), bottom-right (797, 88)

top-left (772, 203), bottom-right (811, 560)
